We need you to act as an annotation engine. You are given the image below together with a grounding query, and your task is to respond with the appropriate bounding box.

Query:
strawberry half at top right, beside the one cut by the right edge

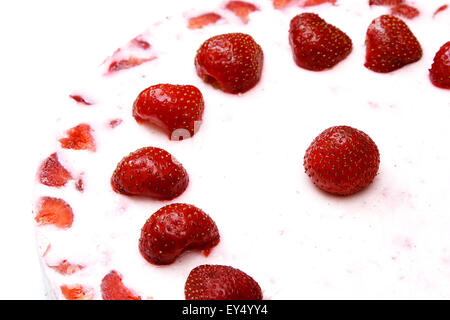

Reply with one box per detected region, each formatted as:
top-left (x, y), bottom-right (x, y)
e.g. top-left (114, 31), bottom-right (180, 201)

top-left (364, 15), bottom-right (422, 73)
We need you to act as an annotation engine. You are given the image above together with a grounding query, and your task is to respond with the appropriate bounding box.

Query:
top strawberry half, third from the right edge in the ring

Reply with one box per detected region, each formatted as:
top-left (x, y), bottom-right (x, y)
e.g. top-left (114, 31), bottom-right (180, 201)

top-left (289, 13), bottom-right (352, 71)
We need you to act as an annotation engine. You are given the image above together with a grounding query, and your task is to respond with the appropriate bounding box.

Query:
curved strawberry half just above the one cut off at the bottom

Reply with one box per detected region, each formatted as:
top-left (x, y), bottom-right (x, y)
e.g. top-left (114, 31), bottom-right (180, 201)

top-left (139, 203), bottom-right (220, 265)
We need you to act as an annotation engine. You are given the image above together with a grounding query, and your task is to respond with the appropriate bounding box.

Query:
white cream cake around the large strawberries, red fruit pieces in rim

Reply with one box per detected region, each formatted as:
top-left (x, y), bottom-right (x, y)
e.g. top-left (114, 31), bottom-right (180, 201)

top-left (33, 0), bottom-right (450, 299)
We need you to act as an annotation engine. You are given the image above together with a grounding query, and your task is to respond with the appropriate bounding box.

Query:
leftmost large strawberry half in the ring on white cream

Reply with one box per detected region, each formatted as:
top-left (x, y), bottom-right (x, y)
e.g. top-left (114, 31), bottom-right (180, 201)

top-left (111, 147), bottom-right (189, 200)
